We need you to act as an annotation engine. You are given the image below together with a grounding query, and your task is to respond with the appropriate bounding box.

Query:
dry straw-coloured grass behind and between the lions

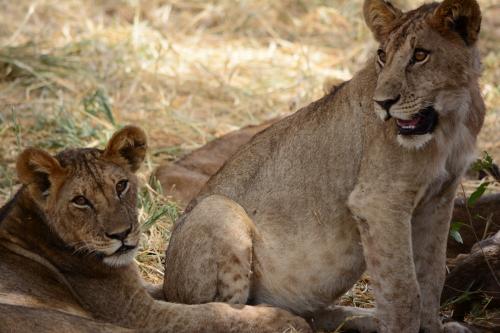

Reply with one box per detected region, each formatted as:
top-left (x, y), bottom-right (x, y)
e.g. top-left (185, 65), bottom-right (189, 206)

top-left (0, 0), bottom-right (500, 326)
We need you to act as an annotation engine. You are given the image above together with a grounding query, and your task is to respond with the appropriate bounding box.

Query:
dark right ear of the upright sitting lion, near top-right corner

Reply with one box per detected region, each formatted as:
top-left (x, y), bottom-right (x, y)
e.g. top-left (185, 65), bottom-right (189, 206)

top-left (431, 0), bottom-right (481, 45)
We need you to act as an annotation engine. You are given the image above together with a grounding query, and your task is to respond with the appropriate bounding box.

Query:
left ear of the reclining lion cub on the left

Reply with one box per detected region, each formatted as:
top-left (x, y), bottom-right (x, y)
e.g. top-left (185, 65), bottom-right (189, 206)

top-left (16, 148), bottom-right (65, 197)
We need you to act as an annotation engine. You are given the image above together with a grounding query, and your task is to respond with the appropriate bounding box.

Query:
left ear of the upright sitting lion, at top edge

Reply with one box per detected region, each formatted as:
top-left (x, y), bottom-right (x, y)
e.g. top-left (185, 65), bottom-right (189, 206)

top-left (363, 0), bottom-right (403, 43)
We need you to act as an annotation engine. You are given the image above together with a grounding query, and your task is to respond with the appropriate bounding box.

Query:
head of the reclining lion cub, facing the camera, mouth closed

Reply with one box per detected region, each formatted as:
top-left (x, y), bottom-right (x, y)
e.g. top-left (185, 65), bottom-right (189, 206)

top-left (17, 126), bottom-right (146, 266)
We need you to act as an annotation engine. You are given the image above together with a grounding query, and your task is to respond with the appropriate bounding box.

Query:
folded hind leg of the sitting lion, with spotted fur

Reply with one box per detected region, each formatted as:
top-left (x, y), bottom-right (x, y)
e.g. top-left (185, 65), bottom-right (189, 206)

top-left (163, 195), bottom-right (254, 304)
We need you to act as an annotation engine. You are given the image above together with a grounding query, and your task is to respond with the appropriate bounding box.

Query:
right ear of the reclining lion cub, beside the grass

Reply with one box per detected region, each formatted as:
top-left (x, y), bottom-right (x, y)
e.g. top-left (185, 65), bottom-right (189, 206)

top-left (103, 126), bottom-right (147, 172)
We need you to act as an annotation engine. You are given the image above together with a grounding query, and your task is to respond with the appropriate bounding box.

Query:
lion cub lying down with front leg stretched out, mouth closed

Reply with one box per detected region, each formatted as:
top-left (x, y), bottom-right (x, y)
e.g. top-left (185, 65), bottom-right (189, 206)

top-left (0, 127), bottom-right (309, 333)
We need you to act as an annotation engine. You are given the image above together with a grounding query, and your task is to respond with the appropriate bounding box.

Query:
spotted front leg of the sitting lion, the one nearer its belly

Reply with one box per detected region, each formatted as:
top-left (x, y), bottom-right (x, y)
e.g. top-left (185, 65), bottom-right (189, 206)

top-left (348, 182), bottom-right (421, 333)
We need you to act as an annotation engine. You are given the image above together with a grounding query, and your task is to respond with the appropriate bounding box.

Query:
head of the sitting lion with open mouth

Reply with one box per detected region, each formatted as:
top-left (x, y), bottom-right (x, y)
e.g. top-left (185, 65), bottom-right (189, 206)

top-left (364, 0), bottom-right (481, 149)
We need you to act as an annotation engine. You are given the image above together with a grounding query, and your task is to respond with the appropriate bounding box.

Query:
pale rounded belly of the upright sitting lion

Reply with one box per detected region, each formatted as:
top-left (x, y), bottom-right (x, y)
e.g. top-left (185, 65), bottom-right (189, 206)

top-left (251, 211), bottom-right (365, 314)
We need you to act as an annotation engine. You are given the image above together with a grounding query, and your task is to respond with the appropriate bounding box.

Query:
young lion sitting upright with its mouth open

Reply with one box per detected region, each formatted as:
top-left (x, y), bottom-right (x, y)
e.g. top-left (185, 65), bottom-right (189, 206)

top-left (164, 0), bottom-right (484, 333)
